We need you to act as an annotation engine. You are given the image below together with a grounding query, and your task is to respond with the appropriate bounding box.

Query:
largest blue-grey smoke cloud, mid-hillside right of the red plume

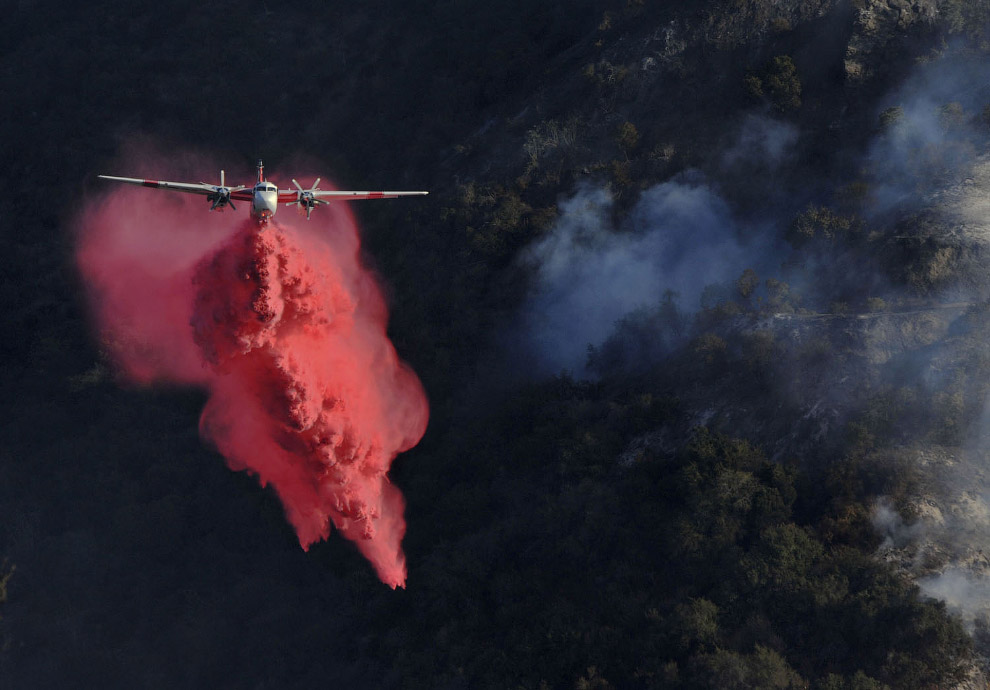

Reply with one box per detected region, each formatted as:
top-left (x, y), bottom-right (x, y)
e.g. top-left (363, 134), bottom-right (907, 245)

top-left (522, 174), bottom-right (759, 376)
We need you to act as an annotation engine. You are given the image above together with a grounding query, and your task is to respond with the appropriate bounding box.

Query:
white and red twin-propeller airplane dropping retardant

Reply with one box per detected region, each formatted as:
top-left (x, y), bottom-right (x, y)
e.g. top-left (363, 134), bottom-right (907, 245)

top-left (99, 160), bottom-right (429, 225)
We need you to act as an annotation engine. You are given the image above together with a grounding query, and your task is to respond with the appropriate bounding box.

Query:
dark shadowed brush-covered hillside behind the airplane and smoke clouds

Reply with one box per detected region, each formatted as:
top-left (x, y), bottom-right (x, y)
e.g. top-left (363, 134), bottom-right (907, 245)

top-left (0, 0), bottom-right (990, 690)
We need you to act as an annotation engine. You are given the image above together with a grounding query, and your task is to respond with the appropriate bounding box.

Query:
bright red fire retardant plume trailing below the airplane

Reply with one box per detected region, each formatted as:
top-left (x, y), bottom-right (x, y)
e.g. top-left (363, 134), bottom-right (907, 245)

top-left (77, 173), bottom-right (428, 588)
